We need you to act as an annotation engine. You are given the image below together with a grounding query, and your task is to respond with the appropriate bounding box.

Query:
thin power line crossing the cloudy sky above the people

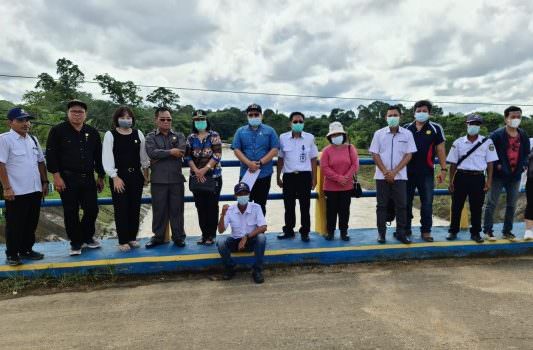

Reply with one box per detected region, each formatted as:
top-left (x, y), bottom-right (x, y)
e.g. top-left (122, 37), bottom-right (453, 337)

top-left (0, 73), bottom-right (533, 107)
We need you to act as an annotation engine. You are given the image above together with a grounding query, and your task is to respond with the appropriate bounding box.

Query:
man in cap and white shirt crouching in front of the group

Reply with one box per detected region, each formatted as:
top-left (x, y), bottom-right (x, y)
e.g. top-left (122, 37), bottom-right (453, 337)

top-left (217, 182), bottom-right (267, 283)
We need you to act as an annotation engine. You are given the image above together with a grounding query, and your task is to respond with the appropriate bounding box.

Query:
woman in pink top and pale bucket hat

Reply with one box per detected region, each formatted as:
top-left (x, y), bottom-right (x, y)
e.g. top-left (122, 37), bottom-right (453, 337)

top-left (320, 122), bottom-right (359, 241)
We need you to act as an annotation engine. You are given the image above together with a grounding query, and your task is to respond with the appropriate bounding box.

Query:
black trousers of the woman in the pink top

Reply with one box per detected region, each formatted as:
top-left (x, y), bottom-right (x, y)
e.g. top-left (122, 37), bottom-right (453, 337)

top-left (324, 191), bottom-right (352, 234)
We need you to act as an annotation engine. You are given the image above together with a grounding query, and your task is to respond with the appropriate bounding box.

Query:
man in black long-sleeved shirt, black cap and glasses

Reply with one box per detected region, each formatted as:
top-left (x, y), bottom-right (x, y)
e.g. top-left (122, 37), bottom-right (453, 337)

top-left (46, 100), bottom-right (105, 255)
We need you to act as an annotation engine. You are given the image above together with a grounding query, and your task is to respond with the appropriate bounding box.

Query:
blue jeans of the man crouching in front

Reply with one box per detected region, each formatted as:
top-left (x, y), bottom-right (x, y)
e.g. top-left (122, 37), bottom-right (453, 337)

top-left (217, 233), bottom-right (266, 271)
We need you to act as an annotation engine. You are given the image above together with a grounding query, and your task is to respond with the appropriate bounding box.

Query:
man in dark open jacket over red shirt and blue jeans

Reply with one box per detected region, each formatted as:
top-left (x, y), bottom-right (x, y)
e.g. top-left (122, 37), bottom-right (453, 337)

top-left (483, 106), bottom-right (530, 242)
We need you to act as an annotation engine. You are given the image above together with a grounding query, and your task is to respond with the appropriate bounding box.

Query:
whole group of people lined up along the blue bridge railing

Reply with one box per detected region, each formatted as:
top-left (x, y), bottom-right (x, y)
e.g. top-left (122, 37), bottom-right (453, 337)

top-left (0, 100), bottom-right (533, 283)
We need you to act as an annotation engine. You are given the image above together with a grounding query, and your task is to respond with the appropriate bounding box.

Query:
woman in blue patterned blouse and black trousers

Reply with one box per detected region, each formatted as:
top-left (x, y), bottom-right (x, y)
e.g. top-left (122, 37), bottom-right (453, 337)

top-left (185, 110), bottom-right (222, 245)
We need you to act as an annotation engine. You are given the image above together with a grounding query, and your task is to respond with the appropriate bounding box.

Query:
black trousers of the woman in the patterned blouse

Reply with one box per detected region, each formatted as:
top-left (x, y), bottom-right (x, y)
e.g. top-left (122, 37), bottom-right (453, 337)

top-left (193, 176), bottom-right (222, 240)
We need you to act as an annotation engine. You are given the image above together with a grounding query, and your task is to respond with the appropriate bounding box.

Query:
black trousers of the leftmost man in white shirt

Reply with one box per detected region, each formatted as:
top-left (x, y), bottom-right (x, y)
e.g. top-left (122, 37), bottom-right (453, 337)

top-left (6, 192), bottom-right (42, 257)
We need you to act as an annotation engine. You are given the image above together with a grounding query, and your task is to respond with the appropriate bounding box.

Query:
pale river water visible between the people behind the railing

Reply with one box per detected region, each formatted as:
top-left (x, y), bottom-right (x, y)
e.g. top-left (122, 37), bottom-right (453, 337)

top-left (139, 149), bottom-right (449, 237)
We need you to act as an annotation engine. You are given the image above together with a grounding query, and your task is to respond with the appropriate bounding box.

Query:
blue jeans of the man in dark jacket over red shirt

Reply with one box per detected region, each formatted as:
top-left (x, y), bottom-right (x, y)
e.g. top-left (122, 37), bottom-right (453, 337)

top-left (483, 177), bottom-right (520, 234)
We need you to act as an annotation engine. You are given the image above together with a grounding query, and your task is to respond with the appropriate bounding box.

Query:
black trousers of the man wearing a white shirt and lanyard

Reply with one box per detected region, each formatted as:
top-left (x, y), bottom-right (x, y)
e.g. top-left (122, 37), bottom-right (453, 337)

top-left (283, 171), bottom-right (313, 234)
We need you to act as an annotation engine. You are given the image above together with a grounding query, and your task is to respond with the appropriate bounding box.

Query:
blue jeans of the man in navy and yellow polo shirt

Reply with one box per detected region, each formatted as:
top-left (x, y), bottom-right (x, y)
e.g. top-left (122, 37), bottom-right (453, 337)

top-left (405, 174), bottom-right (435, 233)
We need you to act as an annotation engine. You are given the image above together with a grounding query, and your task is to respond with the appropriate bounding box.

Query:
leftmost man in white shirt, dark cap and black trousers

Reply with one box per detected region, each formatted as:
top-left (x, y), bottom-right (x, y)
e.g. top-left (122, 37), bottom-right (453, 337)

top-left (0, 108), bottom-right (48, 266)
